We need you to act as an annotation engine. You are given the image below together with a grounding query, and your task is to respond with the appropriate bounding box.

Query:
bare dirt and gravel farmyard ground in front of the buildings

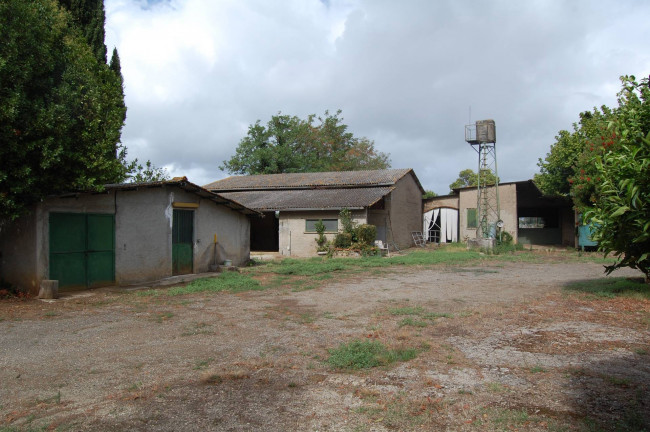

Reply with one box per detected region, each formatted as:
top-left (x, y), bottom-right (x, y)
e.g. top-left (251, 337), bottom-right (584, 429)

top-left (0, 257), bottom-right (650, 431)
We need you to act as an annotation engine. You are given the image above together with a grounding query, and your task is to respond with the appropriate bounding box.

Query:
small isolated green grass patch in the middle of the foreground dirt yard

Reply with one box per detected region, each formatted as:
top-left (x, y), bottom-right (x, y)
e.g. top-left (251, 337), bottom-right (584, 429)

top-left (327, 339), bottom-right (417, 369)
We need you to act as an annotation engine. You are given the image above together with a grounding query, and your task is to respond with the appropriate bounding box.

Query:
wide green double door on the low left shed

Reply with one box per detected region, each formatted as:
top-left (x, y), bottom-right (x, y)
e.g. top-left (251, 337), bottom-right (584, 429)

top-left (50, 213), bottom-right (115, 288)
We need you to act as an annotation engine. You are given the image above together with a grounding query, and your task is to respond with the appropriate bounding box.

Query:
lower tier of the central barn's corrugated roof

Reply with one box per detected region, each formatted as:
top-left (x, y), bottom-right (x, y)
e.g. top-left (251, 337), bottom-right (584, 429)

top-left (221, 186), bottom-right (395, 211)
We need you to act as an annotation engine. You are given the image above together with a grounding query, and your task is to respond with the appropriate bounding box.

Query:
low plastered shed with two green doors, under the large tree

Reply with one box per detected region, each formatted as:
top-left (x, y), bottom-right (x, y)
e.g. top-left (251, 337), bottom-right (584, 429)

top-left (0, 177), bottom-right (260, 292)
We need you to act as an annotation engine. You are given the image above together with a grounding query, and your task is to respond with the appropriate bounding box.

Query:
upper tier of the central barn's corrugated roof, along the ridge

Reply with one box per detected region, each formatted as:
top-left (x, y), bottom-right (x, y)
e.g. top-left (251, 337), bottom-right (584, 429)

top-left (203, 168), bottom-right (421, 192)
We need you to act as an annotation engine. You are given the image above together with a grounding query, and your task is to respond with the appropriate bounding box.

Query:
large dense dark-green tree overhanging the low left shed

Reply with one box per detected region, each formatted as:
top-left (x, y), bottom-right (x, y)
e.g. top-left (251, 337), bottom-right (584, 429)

top-left (0, 0), bottom-right (127, 221)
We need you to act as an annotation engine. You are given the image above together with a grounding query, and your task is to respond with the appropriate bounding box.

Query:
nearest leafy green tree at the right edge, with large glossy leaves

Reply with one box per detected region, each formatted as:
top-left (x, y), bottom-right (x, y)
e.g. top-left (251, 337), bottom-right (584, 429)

top-left (571, 76), bottom-right (650, 283)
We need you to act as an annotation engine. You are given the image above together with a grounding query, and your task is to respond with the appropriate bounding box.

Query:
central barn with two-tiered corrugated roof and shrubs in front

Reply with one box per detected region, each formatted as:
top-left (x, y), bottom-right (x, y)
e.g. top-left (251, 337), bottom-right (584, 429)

top-left (204, 169), bottom-right (424, 256)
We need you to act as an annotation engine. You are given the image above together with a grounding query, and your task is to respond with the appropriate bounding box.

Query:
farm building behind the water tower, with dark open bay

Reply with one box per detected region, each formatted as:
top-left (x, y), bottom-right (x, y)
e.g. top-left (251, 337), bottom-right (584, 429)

top-left (423, 180), bottom-right (576, 246)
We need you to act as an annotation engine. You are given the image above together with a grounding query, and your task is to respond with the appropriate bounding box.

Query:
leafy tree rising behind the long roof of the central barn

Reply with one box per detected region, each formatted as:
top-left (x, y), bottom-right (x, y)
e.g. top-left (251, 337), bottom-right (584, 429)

top-left (220, 110), bottom-right (390, 174)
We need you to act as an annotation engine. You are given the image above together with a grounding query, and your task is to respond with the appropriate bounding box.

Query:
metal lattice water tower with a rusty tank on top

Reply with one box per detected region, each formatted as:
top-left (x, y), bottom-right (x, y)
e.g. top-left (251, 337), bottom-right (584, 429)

top-left (465, 120), bottom-right (503, 239)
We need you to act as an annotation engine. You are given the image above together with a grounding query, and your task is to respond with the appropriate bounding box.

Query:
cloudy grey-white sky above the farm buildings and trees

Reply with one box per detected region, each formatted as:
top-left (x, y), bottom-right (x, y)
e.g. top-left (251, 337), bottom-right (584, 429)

top-left (104, 0), bottom-right (650, 195)
